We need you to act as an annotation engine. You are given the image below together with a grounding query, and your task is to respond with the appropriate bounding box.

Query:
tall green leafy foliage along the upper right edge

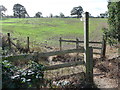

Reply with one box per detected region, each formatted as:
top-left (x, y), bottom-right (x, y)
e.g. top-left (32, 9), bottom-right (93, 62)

top-left (108, 1), bottom-right (120, 42)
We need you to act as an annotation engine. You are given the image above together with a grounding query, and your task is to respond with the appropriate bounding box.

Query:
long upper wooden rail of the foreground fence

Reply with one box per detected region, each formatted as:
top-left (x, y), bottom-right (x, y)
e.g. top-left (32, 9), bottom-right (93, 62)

top-left (2, 47), bottom-right (84, 61)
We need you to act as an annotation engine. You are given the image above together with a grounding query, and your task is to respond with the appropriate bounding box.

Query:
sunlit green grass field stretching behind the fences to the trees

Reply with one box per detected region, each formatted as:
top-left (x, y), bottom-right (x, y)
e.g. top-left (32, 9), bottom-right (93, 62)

top-left (0, 18), bottom-right (107, 47)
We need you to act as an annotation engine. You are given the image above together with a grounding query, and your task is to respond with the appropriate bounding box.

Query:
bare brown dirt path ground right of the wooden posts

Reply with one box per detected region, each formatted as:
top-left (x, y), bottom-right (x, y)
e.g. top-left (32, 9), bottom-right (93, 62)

top-left (94, 45), bottom-right (120, 89)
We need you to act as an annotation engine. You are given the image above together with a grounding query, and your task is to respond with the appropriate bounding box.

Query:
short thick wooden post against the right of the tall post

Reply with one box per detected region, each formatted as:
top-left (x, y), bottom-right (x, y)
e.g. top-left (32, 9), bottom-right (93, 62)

top-left (89, 47), bottom-right (93, 83)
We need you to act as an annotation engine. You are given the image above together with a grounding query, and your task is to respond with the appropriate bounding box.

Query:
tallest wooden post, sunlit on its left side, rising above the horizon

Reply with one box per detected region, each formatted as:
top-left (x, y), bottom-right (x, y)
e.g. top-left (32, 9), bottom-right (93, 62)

top-left (84, 12), bottom-right (90, 80)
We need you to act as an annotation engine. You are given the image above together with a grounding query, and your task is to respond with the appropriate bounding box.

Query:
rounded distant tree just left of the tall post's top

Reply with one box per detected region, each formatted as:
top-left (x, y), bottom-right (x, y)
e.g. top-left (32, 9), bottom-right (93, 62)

top-left (71, 6), bottom-right (83, 18)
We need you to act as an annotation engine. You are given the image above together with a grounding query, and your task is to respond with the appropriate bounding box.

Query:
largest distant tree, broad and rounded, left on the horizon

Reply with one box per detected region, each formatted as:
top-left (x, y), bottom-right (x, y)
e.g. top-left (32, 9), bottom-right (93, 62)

top-left (13, 4), bottom-right (29, 18)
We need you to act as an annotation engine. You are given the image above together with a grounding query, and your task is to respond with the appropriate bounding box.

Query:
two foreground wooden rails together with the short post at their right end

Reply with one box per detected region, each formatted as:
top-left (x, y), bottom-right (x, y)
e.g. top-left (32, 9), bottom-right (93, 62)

top-left (2, 47), bottom-right (93, 81)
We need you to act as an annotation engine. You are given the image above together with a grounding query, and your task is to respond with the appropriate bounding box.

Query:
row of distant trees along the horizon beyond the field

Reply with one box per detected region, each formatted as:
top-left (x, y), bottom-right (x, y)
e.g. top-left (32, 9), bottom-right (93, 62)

top-left (0, 4), bottom-right (108, 18)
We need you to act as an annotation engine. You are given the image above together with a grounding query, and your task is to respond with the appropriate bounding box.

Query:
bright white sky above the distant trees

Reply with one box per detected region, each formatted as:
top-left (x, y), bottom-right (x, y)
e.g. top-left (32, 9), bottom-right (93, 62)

top-left (0, 0), bottom-right (108, 16)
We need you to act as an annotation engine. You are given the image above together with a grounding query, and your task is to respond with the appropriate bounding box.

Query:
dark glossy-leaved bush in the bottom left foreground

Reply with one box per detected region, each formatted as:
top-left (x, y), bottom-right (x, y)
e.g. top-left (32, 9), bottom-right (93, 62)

top-left (2, 60), bottom-right (45, 88)
